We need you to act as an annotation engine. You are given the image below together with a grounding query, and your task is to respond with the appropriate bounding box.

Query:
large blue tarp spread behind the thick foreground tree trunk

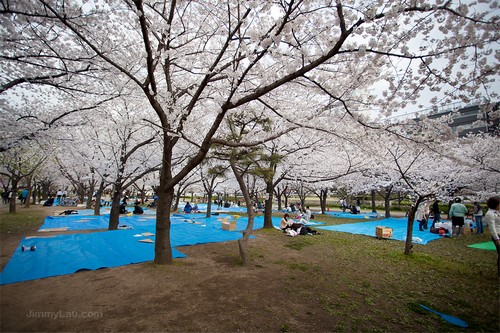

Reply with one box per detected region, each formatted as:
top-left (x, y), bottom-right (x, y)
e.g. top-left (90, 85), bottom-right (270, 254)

top-left (1, 223), bottom-right (241, 284)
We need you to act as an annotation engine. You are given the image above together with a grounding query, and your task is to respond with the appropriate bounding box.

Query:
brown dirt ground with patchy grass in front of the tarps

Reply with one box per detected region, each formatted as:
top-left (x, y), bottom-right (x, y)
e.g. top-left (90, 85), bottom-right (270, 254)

top-left (0, 207), bottom-right (500, 332)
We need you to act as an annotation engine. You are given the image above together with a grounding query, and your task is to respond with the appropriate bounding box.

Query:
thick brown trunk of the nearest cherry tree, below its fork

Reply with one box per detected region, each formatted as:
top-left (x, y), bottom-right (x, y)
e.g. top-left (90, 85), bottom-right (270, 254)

top-left (154, 184), bottom-right (174, 265)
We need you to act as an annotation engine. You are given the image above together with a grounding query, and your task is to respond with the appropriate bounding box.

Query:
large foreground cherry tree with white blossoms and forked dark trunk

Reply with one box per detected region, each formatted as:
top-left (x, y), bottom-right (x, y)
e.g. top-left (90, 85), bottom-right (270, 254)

top-left (0, 0), bottom-right (499, 264)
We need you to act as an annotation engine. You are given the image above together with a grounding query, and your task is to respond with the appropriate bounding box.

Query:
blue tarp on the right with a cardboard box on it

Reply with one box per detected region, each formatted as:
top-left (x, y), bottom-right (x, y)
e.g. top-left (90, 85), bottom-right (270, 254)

top-left (317, 217), bottom-right (442, 244)
